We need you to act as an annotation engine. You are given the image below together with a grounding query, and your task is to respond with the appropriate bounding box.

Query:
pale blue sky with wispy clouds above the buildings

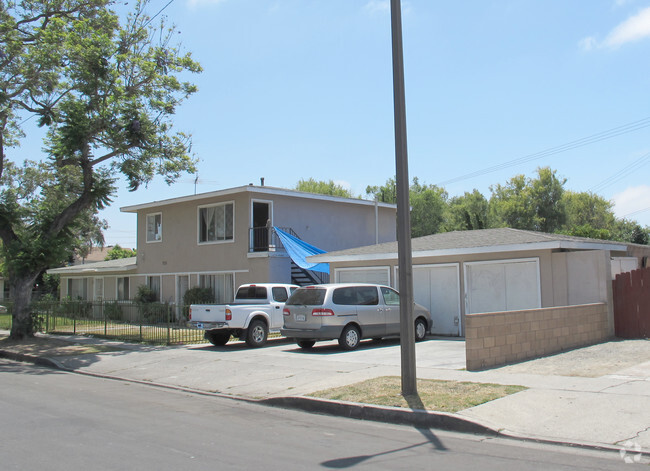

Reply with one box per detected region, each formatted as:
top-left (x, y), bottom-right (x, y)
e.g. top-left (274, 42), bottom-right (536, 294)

top-left (11, 0), bottom-right (650, 247)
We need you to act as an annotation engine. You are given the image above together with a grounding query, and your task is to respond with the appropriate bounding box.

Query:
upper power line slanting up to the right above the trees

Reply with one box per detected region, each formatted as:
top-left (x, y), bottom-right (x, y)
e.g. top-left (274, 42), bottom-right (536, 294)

top-left (436, 117), bottom-right (650, 186)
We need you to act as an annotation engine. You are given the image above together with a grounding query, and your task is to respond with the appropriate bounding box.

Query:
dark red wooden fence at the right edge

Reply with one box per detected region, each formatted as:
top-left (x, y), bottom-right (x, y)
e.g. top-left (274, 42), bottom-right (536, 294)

top-left (612, 268), bottom-right (650, 339)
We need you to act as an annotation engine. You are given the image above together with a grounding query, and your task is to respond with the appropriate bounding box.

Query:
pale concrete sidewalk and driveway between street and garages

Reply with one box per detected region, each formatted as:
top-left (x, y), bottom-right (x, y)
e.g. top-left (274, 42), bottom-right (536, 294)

top-left (0, 331), bottom-right (650, 462)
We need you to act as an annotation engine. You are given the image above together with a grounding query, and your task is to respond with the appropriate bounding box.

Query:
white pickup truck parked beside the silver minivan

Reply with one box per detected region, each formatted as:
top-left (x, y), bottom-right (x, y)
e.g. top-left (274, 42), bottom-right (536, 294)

top-left (188, 283), bottom-right (298, 347)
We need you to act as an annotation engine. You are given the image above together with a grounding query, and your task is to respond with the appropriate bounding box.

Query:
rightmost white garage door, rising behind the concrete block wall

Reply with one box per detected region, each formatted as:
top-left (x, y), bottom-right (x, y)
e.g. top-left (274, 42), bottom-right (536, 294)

top-left (464, 258), bottom-right (542, 314)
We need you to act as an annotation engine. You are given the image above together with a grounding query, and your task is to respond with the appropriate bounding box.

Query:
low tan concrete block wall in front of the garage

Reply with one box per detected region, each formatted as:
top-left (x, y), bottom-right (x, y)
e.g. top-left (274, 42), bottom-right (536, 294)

top-left (465, 303), bottom-right (610, 371)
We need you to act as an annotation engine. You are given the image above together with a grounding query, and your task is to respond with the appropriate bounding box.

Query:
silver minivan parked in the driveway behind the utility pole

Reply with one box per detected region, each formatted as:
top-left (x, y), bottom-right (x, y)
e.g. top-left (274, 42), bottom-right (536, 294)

top-left (280, 283), bottom-right (433, 350)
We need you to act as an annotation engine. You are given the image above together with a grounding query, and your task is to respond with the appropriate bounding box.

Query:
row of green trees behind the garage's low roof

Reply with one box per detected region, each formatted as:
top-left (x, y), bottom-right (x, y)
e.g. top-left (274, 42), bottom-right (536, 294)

top-left (366, 167), bottom-right (650, 244)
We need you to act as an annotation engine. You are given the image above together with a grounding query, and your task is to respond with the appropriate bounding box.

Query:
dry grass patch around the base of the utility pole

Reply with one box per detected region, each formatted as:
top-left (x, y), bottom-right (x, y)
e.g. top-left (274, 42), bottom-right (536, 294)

top-left (309, 376), bottom-right (526, 412)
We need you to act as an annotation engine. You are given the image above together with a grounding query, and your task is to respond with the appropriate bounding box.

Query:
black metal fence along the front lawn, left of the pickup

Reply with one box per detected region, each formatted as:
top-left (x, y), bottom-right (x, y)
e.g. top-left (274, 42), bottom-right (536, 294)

top-left (0, 300), bottom-right (206, 345)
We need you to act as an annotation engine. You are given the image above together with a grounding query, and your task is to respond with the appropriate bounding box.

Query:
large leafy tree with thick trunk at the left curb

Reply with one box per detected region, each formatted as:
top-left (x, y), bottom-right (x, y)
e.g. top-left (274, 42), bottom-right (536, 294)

top-left (0, 0), bottom-right (200, 338)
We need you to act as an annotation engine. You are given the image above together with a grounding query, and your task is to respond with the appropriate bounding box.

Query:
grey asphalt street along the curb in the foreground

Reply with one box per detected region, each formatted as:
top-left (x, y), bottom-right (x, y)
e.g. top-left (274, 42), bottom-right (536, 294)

top-left (0, 360), bottom-right (636, 471)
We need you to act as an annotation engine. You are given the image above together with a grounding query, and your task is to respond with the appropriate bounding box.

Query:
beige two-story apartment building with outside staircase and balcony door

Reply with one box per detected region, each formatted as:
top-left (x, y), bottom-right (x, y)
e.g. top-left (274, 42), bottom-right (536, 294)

top-left (49, 185), bottom-right (396, 304)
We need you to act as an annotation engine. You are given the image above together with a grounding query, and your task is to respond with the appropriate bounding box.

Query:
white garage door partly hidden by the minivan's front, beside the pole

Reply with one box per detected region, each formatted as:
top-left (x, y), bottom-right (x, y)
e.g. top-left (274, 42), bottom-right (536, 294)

top-left (413, 264), bottom-right (460, 335)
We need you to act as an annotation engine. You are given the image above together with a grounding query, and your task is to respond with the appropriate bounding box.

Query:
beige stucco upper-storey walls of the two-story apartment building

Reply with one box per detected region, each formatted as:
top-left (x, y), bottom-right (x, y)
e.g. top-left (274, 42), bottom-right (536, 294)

top-left (137, 192), bottom-right (395, 281)
